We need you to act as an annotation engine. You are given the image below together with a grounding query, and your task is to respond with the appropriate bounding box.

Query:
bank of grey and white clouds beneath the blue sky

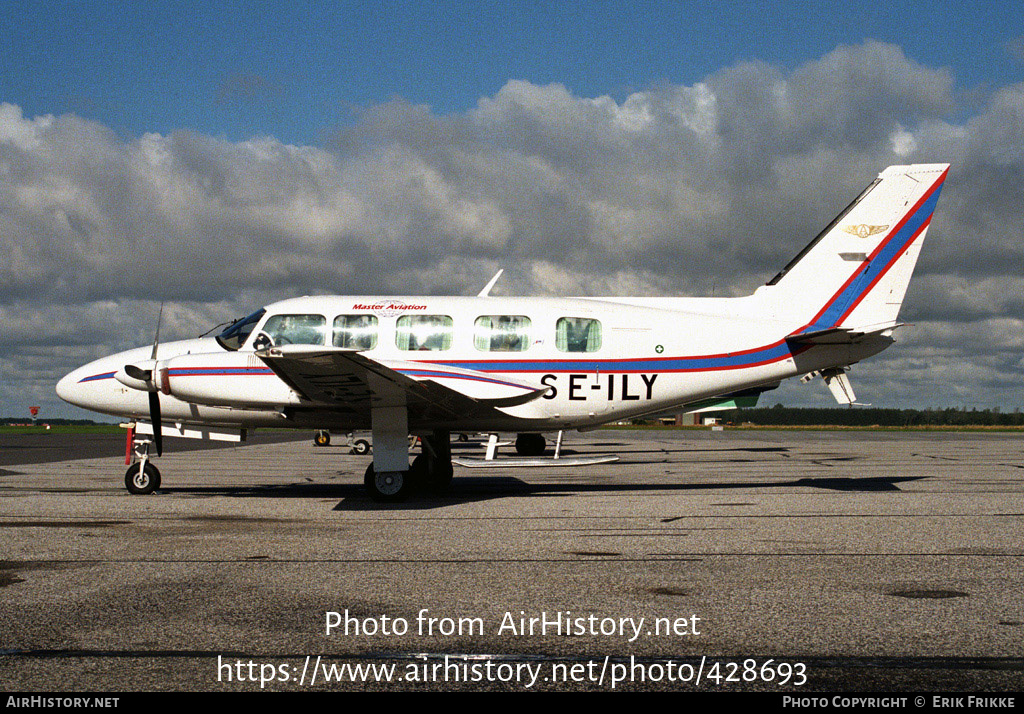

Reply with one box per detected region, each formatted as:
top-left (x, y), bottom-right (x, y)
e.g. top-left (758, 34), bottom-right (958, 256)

top-left (0, 41), bottom-right (1024, 413)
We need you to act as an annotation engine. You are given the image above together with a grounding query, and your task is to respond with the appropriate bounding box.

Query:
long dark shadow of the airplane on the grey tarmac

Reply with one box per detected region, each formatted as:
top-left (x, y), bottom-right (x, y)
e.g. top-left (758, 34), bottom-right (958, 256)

top-left (155, 476), bottom-right (924, 511)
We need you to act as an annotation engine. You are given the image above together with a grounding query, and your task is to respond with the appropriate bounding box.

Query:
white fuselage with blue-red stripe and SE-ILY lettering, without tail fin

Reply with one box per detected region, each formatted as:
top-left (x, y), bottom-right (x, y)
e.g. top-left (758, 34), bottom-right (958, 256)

top-left (57, 296), bottom-right (891, 431)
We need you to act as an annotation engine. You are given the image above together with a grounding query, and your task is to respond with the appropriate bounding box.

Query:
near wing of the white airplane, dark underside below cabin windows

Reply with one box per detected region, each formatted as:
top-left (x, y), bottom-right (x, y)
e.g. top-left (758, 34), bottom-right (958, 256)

top-left (256, 344), bottom-right (549, 417)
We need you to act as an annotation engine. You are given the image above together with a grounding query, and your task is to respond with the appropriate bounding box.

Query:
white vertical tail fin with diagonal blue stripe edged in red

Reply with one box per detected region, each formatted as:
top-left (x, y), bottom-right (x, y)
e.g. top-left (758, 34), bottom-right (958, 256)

top-left (758, 164), bottom-right (949, 334)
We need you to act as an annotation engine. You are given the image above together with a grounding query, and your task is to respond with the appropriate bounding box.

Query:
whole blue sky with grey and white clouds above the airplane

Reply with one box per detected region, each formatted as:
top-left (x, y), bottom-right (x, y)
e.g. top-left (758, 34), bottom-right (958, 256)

top-left (0, 1), bottom-right (1024, 417)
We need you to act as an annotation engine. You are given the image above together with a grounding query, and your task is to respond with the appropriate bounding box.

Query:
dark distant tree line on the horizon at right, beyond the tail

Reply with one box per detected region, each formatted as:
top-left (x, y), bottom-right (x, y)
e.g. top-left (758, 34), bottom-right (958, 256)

top-left (711, 405), bottom-right (1024, 426)
